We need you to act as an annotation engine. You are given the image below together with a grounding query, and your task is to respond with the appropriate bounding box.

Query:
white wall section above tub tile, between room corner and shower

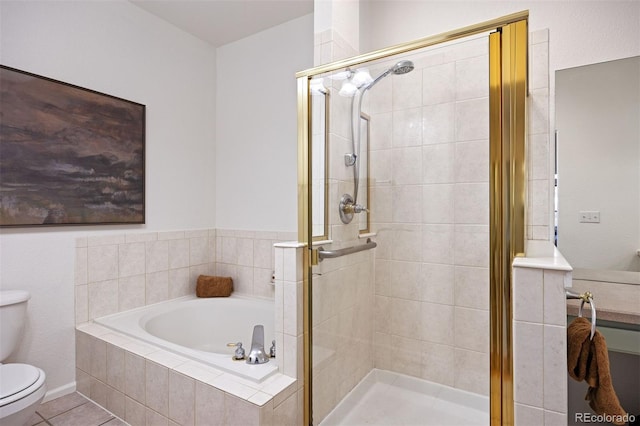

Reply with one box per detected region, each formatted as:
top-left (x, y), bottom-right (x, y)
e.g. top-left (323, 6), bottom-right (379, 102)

top-left (215, 15), bottom-right (313, 231)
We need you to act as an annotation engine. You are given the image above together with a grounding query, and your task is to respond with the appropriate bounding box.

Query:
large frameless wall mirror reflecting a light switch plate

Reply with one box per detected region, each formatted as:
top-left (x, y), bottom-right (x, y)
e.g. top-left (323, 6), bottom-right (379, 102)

top-left (556, 57), bottom-right (640, 276)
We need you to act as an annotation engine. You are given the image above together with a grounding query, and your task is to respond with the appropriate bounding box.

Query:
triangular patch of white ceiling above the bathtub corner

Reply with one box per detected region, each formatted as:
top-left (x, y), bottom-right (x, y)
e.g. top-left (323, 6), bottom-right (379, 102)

top-left (131, 0), bottom-right (313, 47)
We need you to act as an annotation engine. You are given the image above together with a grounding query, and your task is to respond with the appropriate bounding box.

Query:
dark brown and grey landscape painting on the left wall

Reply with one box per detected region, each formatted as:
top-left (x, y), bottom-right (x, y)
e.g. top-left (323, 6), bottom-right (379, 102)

top-left (0, 66), bottom-right (145, 227)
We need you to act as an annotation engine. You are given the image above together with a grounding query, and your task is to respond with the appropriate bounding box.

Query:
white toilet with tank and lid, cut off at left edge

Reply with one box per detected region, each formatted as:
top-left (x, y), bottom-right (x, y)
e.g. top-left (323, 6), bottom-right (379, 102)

top-left (0, 290), bottom-right (47, 426)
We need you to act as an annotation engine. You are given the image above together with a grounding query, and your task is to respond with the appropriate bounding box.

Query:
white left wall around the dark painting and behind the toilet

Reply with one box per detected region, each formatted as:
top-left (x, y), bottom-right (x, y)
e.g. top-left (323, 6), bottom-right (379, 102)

top-left (0, 1), bottom-right (216, 400)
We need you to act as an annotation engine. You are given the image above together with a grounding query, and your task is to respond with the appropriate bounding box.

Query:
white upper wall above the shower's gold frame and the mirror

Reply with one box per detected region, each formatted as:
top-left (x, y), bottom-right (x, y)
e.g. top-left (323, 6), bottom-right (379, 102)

top-left (362, 0), bottom-right (640, 71)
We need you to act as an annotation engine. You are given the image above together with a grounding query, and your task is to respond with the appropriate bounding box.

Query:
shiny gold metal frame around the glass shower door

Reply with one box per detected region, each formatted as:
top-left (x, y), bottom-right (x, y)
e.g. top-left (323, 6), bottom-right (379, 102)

top-left (296, 11), bottom-right (529, 426)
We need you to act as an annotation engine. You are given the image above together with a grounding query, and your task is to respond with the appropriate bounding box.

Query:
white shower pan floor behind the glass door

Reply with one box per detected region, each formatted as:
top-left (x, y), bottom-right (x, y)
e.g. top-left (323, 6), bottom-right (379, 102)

top-left (320, 369), bottom-right (489, 426)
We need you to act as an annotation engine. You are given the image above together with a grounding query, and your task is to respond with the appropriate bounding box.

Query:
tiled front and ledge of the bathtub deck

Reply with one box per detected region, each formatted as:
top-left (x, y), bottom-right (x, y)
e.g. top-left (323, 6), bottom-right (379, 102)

top-left (76, 323), bottom-right (302, 426)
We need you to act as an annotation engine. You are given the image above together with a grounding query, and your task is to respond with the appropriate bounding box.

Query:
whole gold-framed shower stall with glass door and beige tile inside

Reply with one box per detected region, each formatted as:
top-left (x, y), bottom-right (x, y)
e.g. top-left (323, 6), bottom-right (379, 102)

top-left (297, 12), bottom-right (527, 425)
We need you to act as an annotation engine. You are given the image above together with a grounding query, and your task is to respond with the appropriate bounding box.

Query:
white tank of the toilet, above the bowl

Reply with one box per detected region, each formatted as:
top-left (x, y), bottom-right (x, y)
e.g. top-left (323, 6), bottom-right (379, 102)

top-left (0, 290), bottom-right (31, 362)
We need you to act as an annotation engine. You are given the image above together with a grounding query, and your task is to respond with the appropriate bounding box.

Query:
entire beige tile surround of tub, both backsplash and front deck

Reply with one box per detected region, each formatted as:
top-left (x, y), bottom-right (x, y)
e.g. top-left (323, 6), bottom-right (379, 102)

top-left (76, 230), bottom-right (304, 425)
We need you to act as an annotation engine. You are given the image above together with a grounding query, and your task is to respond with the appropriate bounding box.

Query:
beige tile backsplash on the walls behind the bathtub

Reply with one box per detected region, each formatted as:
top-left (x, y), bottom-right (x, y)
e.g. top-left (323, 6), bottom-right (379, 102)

top-left (75, 229), bottom-right (296, 324)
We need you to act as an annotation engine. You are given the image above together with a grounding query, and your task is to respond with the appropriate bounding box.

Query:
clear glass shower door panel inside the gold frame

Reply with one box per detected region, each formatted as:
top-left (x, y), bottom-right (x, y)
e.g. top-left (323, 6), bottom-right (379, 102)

top-left (305, 14), bottom-right (528, 425)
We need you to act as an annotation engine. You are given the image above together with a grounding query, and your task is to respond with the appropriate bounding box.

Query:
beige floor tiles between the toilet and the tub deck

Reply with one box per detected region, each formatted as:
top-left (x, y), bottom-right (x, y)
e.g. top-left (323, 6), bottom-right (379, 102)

top-left (29, 392), bottom-right (127, 426)
